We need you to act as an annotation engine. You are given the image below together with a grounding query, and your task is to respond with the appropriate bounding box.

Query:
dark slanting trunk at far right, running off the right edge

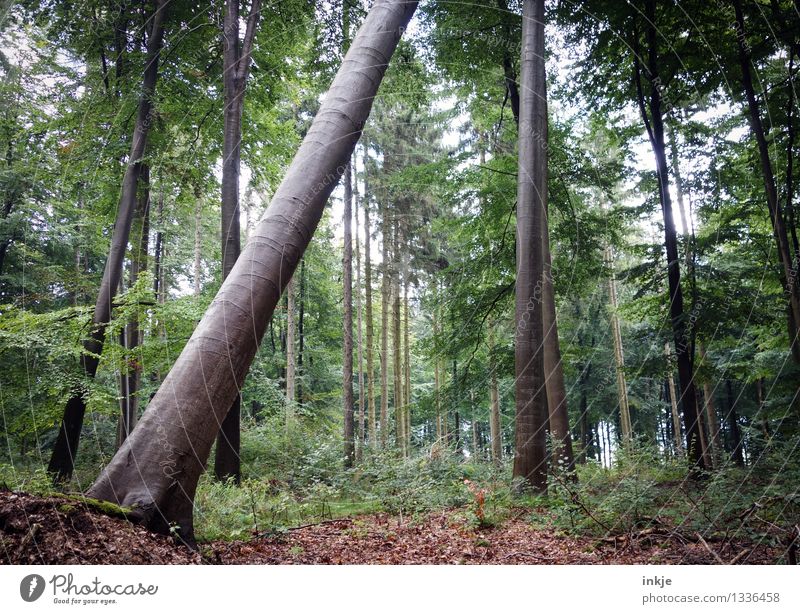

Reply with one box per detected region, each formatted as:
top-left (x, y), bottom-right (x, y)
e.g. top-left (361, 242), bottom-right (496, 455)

top-left (733, 0), bottom-right (800, 362)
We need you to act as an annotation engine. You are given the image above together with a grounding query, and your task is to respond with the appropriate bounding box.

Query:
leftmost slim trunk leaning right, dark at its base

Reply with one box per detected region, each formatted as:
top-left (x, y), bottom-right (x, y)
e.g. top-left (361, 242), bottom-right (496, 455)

top-left (47, 0), bottom-right (167, 481)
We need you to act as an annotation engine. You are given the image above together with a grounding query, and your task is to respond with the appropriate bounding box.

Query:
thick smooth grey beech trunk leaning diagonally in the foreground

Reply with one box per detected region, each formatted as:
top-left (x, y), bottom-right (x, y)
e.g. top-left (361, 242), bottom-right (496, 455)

top-left (89, 0), bottom-right (417, 545)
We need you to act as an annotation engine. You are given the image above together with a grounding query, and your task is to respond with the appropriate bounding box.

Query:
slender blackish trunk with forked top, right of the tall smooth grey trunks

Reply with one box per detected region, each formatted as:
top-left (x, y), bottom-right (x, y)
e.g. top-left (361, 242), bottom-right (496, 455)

top-left (634, 0), bottom-right (705, 469)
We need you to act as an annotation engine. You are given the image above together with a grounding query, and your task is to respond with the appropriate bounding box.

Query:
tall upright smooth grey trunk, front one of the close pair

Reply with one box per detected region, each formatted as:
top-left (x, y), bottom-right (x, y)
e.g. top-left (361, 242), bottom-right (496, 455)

top-left (514, 0), bottom-right (547, 492)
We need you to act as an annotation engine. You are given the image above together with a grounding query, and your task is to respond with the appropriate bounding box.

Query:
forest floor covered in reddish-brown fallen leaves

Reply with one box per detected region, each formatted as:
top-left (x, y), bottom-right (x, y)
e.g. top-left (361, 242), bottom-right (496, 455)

top-left (0, 491), bottom-right (780, 564)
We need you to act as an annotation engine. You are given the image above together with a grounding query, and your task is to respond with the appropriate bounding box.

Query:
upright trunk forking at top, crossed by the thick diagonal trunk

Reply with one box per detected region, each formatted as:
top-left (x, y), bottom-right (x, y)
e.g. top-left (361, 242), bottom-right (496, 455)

top-left (214, 0), bottom-right (264, 484)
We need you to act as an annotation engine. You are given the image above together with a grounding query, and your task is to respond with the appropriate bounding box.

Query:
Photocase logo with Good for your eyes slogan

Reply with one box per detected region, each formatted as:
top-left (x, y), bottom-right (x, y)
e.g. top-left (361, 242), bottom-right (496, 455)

top-left (19, 573), bottom-right (158, 605)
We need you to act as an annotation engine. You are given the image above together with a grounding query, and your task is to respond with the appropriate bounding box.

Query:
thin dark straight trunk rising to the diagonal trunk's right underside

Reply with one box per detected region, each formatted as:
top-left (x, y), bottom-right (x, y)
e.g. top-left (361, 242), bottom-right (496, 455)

top-left (342, 161), bottom-right (356, 467)
